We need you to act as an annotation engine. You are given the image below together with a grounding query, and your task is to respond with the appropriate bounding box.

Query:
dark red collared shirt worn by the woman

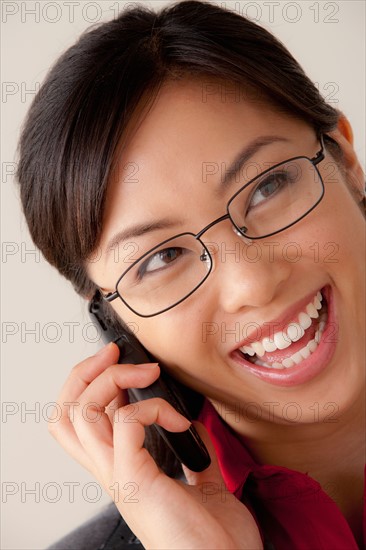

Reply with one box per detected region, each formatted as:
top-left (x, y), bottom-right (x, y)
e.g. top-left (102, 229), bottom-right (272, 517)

top-left (199, 400), bottom-right (366, 550)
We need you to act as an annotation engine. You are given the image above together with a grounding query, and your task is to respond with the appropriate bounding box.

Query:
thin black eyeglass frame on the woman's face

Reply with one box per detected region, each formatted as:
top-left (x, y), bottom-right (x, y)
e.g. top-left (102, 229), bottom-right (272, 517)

top-left (101, 134), bottom-right (326, 318)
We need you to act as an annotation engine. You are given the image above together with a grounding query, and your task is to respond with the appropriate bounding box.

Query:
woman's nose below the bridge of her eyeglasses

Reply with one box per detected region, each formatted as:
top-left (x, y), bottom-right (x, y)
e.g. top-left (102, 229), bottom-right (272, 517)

top-left (211, 229), bottom-right (291, 313)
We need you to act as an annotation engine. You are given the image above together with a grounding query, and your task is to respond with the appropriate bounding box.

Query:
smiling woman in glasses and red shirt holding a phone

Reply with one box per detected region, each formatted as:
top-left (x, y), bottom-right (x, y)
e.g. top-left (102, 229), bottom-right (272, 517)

top-left (18, 2), bottom-right (365, 548)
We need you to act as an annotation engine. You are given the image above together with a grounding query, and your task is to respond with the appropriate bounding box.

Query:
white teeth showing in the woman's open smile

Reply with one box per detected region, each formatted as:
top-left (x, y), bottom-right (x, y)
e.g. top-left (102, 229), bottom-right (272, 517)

top-left (240, 292), bottom-right (327, 369)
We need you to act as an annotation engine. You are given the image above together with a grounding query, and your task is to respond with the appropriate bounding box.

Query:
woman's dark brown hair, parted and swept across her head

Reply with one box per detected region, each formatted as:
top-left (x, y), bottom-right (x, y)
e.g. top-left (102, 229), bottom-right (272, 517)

top-left (18, 1), bottom-right (339, 472)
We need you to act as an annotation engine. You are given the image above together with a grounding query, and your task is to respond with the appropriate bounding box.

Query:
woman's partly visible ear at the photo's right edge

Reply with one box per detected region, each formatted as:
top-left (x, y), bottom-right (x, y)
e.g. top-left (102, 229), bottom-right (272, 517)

top-left (328, 113), bottom-right (366, 202)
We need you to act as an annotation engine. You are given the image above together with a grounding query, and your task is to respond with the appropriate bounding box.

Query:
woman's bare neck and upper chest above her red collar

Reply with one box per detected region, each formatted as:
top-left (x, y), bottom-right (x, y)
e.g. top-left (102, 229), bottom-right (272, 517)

top-left (213, 393), bottom-right (365, 547)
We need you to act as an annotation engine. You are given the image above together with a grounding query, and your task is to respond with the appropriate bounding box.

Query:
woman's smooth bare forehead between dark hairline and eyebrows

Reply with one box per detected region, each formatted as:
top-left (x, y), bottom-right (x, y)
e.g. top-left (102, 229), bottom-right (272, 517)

top-left (102, 79), bottom-right (305, 240)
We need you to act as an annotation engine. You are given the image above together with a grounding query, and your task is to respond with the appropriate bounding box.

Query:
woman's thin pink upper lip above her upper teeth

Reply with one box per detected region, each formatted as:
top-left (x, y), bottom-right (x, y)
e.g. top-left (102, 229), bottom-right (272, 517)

top-left (230, 288), bottom-right (324, 353)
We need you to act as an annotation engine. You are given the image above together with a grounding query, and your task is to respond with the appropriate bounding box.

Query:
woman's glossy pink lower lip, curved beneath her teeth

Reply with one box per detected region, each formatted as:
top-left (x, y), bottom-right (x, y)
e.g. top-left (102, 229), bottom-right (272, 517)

top-left (231, 286), bottom-right (338, 387)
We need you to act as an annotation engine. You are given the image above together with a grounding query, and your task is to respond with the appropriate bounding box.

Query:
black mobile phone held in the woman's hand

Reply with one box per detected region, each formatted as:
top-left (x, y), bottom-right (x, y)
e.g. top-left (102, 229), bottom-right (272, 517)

top-left (89, 292), bottom-right (211, 472)
